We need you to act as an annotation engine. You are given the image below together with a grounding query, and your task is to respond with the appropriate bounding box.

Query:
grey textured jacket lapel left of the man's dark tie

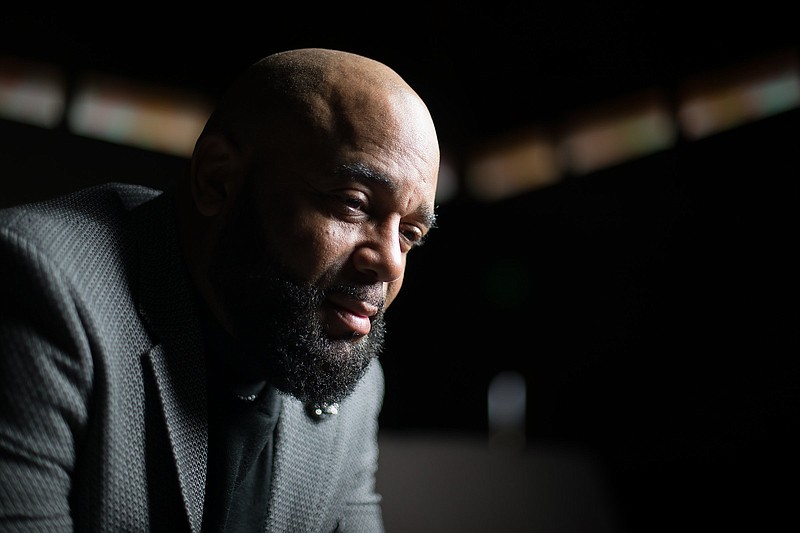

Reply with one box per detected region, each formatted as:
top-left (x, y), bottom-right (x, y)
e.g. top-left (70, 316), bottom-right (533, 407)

top-left (131, 189), bottom-right (208, 532)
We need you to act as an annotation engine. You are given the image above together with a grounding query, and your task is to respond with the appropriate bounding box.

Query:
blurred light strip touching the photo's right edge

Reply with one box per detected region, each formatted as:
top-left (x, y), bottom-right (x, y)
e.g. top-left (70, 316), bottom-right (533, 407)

top-left (678, 47), bottom-right (800, 140)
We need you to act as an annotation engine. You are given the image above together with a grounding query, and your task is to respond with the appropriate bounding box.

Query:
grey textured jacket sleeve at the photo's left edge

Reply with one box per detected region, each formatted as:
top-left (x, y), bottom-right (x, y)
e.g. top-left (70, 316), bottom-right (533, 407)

top-left (0, 229), bottom-right (91, 532)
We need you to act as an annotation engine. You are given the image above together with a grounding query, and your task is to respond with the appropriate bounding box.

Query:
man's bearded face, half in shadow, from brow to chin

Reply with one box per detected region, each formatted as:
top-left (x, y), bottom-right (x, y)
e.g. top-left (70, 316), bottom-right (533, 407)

top-left (210, 94), bottom-right (438, 402)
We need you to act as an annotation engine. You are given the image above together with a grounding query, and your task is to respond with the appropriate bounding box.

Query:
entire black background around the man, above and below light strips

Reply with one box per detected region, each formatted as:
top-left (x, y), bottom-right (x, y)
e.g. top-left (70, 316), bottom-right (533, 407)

top-left (0, 2), bottom-right (800, 532)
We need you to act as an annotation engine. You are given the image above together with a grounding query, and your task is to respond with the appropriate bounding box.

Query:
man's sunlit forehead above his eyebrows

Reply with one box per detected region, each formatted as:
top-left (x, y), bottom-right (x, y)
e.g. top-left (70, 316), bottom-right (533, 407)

top-left (260, 78), bottom-right (439, 214)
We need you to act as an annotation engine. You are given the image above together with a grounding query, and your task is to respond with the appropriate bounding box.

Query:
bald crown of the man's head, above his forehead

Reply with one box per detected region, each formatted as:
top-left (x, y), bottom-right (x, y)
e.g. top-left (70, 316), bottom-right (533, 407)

top-left (198, 48), bottom-right (438, 167)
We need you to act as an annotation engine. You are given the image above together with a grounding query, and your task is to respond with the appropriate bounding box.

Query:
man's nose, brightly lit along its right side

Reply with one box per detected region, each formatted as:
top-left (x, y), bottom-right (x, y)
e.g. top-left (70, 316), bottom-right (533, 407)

top-left (353, 219), bottom-right (405, 283)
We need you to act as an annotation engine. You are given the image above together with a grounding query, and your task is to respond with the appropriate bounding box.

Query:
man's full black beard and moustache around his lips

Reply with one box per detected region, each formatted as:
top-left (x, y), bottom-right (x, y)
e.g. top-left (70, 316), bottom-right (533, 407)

top-left (210, 195), bottom-right (386, 403)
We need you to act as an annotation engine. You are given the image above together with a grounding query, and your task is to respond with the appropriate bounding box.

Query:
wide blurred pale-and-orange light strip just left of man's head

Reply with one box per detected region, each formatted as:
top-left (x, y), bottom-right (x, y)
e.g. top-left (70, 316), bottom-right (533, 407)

top-left (68, 74), bottom-right (211, 157)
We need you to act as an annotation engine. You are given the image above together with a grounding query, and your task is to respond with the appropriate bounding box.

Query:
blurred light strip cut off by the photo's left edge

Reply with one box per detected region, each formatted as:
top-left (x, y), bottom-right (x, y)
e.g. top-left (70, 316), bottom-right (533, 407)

top-left (0, 57), bottom-right (66, 128)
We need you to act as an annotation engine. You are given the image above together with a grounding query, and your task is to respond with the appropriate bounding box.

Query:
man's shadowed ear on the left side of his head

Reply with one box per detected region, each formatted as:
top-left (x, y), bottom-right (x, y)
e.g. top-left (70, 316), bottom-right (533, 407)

top-left (191, 135), bottom-right (244, 216)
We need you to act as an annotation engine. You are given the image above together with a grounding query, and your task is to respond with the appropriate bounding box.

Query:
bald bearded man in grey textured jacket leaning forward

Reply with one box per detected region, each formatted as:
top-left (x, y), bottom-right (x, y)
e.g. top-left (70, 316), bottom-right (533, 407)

top-left (0, 49), bottom-right (439, 533)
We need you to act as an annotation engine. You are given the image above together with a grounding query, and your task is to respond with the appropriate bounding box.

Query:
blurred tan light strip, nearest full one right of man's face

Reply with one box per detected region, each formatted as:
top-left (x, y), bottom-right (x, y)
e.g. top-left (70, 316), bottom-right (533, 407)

top-left (464, 130), bottom-right (562, 201)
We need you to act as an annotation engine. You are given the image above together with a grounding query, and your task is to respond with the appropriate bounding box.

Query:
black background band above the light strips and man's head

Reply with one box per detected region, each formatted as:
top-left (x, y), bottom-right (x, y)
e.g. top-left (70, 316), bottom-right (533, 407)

top-left (0, 4), bottom-right (797, 153)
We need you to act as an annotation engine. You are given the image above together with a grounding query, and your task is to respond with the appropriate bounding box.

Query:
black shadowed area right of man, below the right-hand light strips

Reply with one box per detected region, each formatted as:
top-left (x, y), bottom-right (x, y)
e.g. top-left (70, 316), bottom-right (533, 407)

top-left (383, 106), bottom-right (800, 532)
